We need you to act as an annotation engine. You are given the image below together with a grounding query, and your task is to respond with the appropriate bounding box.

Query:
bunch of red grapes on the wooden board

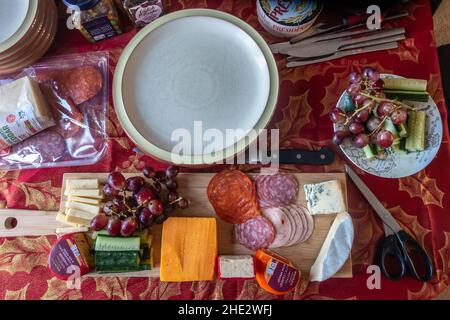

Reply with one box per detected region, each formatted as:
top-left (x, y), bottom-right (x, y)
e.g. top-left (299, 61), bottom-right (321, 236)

top-left (91, 166), bottom-right (189, 237)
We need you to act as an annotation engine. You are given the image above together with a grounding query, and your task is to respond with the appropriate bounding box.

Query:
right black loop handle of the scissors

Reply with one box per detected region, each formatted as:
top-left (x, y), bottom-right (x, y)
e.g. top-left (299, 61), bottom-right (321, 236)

top-left (397, 230), bottom-right (433, 282)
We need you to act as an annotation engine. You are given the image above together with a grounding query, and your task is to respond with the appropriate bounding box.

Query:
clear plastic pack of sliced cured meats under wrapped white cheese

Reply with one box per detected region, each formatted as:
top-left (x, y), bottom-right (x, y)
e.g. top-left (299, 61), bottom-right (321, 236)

top-left (0, 52), bottom-right (109, 171)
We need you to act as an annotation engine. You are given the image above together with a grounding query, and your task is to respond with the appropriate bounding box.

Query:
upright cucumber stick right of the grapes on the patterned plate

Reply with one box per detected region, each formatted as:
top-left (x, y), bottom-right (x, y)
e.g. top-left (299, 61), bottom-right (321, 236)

top-left (405, 111), bottom-right (427, 152)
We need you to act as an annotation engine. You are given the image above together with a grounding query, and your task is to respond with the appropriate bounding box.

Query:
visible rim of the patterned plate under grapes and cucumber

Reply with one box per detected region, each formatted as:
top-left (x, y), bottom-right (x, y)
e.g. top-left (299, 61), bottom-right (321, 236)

top-left (333, 74), bottom-right (443, 179)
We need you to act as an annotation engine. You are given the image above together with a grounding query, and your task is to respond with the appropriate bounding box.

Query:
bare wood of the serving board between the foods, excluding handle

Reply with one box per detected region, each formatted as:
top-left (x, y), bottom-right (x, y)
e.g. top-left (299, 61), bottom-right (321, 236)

top-left (61, 173), bottom-right (353, 278)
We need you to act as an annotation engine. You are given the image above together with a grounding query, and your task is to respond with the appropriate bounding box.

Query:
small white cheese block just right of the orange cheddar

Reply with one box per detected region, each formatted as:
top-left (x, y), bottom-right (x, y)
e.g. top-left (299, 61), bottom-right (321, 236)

top-left (218, 255), bottom-right (255, 279)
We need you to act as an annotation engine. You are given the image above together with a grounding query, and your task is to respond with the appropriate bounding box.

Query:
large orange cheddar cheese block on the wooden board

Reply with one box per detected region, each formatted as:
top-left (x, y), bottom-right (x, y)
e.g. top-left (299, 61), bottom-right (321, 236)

top-left (160, 217), bottom-right (217, 282)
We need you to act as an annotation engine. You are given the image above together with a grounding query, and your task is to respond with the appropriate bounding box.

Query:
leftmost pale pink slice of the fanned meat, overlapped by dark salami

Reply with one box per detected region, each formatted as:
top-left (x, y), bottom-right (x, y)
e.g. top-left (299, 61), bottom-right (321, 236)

top-left (262, 207), bottom-right (293, 248)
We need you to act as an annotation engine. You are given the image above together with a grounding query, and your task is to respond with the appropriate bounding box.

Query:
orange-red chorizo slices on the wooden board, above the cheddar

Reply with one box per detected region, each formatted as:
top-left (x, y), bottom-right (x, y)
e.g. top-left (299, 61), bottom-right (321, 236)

top-left (207, 170), bottom-right (259, 224)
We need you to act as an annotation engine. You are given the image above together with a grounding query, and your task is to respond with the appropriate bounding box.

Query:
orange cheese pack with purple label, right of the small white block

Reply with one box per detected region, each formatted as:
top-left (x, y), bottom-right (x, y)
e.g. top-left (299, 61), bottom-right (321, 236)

top-left (255, 249), bottom-right (301, 295)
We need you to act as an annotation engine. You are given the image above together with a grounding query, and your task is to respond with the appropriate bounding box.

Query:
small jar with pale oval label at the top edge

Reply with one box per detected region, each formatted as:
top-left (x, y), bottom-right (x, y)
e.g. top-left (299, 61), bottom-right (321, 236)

top-left (121, 0), bottom-right (164, 28)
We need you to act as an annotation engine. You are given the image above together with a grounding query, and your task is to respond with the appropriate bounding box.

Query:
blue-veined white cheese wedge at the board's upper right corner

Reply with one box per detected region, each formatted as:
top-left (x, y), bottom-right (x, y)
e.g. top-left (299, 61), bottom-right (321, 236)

top-left (303, 180), bottom-right (347, 215)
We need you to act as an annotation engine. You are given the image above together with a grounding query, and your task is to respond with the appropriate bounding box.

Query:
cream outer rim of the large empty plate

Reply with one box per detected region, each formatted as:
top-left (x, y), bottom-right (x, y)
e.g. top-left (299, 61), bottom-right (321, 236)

top-left (113, 9), bottom-right (279, 165)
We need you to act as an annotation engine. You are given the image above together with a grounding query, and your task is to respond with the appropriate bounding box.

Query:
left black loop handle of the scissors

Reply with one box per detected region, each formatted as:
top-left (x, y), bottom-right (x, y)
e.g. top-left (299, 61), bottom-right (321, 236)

top-left (379, 235), bottom-right (406, 280)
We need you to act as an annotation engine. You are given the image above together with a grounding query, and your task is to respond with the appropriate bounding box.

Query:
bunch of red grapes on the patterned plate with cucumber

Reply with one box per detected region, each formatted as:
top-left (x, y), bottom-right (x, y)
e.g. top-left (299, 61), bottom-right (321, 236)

top-left (330, 68), bottom-right (408, 149)
